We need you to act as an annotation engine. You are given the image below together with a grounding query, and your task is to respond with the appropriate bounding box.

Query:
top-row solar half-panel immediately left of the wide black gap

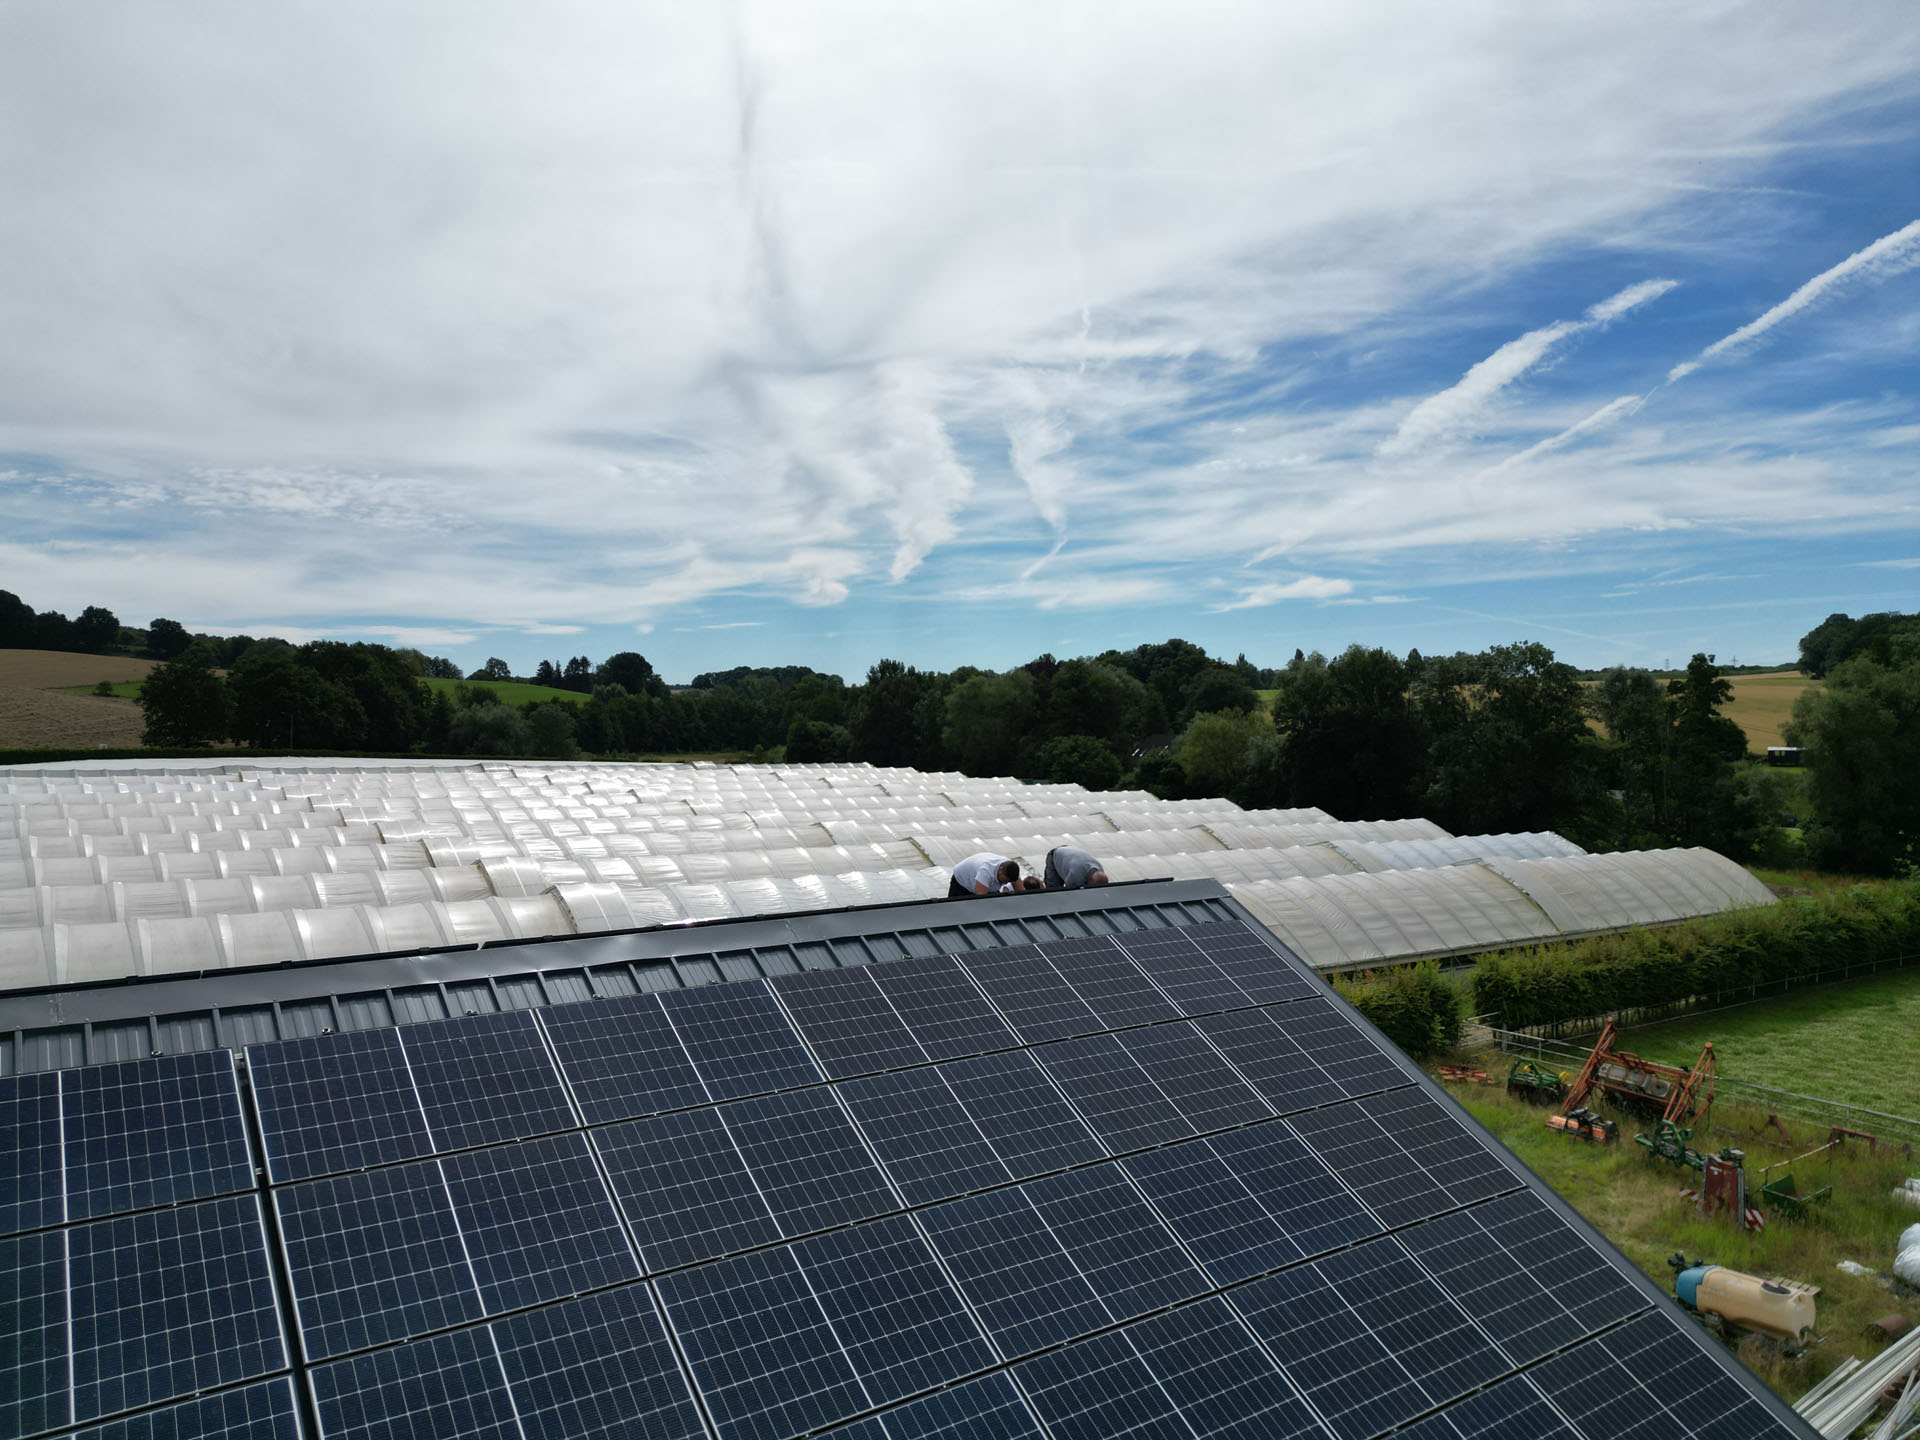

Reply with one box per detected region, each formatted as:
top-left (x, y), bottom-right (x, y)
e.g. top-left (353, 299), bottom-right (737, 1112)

top-left (60, 1050), bottom-right (253, 1219)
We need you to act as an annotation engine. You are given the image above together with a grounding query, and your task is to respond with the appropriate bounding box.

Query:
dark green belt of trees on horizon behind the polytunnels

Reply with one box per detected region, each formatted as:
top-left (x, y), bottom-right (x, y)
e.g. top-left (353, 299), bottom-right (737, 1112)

top-left (0, 591), bottom-right (1920, 874)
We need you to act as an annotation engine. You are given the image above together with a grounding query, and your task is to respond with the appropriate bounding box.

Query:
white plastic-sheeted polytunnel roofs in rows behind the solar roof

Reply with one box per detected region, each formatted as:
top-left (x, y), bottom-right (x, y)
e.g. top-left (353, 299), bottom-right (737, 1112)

top-left (0, 760), bottom-right (1772, 989)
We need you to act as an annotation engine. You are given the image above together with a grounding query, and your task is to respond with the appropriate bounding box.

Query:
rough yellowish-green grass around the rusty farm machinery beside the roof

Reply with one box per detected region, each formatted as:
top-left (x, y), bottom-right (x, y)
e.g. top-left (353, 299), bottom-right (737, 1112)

top-left (1448, 1090), bottom-right (1920, 1400)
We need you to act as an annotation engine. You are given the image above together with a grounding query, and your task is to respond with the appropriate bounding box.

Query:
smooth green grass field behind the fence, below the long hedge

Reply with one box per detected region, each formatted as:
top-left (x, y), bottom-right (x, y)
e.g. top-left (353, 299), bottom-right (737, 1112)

top-left (1597, 968), bottom-right (1920, 1113)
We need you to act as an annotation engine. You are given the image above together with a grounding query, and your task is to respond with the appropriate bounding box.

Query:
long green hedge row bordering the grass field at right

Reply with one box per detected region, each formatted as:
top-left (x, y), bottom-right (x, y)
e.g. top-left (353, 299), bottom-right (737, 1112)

top-left (1473, 881), bottom-right (1920, 1029)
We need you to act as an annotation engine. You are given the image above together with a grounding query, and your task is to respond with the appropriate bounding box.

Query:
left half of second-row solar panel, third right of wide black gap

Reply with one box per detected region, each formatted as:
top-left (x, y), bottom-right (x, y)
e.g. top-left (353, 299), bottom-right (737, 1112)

top-left (839, 1066), bottom-right (1014, 1204)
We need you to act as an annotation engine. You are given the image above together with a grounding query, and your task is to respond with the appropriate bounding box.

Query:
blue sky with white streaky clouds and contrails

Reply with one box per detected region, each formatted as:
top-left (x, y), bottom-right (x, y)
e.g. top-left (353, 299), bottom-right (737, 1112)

top-left (0, 0), bottom-right (1920, 680)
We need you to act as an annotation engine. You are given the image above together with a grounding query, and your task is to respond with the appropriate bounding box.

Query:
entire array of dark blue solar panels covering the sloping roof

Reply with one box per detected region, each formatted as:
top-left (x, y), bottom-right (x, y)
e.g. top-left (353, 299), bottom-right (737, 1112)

top-left (0, 922), bottom-right (1803, 1440)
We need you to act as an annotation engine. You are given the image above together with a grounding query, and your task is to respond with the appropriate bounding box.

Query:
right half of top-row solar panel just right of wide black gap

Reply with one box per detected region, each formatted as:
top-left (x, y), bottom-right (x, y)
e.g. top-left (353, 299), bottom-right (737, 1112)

top-left (399, 1010), bottom-right (574, 1150)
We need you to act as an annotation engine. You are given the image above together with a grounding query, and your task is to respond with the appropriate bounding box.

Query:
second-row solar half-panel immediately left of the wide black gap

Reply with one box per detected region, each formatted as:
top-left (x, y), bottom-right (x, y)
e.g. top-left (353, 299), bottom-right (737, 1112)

top-left (65, 1196), bottom-right (288, 1421)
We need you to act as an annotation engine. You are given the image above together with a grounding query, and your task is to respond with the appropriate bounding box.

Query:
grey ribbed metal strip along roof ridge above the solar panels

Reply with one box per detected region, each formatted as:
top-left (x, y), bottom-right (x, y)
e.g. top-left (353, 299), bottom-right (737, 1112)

top-left (0, 879), bottom-right (1228, 1075)
